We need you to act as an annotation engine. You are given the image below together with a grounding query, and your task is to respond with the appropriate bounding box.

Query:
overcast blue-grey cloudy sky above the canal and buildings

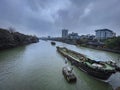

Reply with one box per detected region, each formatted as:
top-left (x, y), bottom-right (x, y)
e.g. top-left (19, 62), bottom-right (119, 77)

top-left (0, 0), bottom-right (120, 36)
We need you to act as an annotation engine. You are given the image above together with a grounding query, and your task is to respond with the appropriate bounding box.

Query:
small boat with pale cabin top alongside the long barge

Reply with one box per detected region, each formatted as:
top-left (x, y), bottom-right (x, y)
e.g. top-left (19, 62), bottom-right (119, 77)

top-left (62, 66), bottom-right (76, 82)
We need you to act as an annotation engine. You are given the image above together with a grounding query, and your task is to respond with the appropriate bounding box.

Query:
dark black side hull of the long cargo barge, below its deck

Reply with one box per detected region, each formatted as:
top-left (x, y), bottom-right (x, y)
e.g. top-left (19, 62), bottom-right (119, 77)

top-left (57, 46), bottom-right (115, 80)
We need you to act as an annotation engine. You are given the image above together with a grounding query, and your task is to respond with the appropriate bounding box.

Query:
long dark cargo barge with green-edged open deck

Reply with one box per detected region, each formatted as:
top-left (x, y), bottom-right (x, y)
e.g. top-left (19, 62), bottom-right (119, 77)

top-left (57, 47), bottom-right (117, 80)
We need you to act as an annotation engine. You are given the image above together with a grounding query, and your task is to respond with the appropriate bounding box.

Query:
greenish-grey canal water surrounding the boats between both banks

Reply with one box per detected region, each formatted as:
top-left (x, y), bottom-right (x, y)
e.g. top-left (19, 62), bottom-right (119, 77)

top-left (0, 41), bottom-right (120, 90)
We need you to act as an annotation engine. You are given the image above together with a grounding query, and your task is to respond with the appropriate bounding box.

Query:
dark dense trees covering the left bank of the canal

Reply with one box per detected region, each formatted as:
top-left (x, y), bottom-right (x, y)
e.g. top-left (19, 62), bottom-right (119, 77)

top-left (0, 28), bottom-right (39, 49)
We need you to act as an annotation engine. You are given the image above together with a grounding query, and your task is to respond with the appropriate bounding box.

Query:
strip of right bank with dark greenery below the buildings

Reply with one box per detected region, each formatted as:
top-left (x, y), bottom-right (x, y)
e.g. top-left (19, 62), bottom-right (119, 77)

top-left (45, 36), bottom-right (120, 53)
